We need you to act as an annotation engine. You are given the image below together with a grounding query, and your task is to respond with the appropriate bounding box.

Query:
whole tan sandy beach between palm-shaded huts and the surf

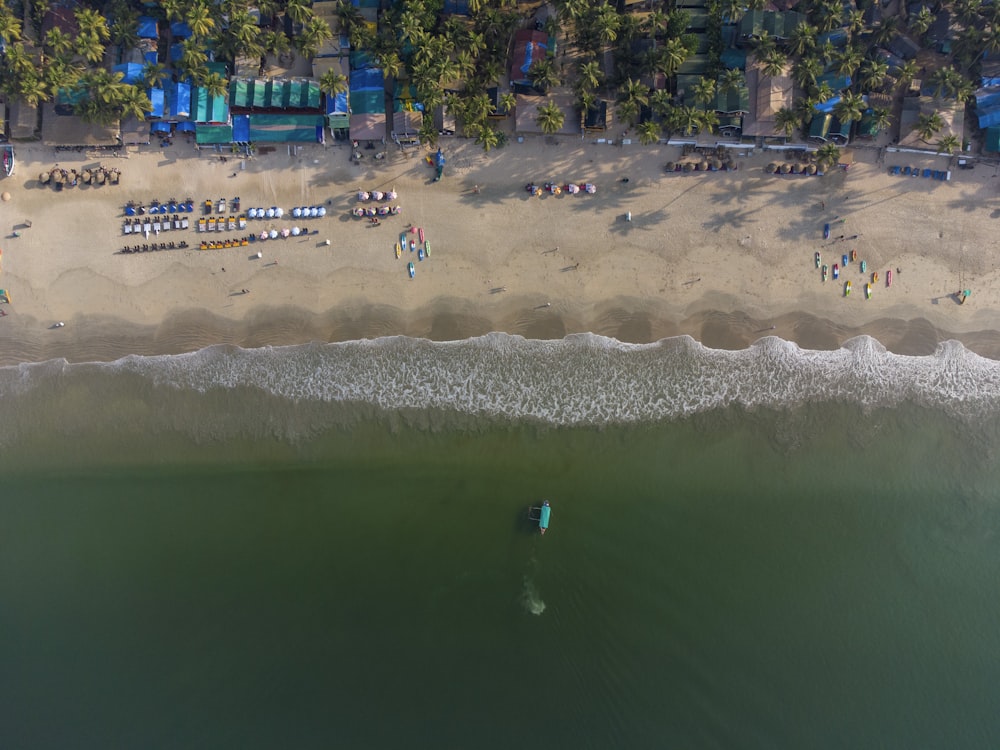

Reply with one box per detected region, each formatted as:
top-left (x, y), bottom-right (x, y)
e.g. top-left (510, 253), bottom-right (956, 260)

top-left (0, 137), bottom-right (1000, 365)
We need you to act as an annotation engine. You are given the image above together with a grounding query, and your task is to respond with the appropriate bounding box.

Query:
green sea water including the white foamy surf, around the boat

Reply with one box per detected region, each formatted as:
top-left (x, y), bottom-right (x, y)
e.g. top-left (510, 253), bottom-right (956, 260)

top-left (0, 335), bottom-right (1000, 748)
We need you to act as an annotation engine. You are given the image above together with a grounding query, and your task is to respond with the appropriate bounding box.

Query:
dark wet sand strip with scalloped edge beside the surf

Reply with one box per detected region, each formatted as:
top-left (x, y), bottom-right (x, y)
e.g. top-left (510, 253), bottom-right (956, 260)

top-left (0, 300), bottom-right (1000, 366)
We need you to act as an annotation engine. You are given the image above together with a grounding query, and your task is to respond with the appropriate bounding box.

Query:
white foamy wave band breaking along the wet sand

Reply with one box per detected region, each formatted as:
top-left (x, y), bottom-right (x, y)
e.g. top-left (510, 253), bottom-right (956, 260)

top-left (0, 334), bottom-right (1000, 426)
